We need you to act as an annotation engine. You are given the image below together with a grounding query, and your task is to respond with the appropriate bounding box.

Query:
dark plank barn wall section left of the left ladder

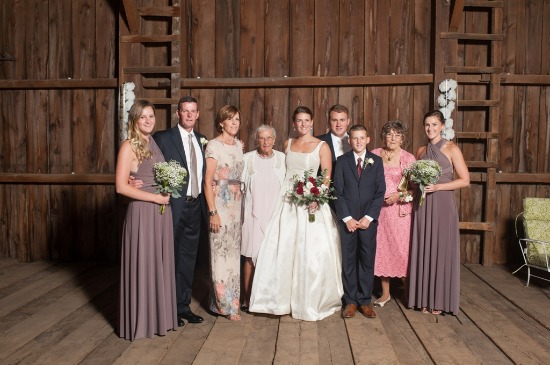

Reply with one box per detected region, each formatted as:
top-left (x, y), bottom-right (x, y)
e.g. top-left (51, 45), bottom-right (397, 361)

top-left (0, 0), bottom-right (118, 261)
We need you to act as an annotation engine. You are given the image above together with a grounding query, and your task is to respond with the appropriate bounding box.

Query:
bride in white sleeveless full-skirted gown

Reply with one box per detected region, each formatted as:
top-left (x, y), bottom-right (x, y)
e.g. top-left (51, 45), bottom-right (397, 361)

top-left (250, 106), bottom-right (344, 321)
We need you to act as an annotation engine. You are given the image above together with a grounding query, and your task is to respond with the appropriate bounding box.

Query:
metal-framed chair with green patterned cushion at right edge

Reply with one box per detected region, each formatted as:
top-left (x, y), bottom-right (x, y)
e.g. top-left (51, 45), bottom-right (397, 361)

top-left (512, 198), bottom-right (550, 286)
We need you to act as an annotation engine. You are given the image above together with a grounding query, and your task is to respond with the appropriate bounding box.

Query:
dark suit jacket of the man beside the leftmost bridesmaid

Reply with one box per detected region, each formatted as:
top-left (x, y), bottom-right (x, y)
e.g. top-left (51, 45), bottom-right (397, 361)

top-left (153, 125), bottom-right (207, 222)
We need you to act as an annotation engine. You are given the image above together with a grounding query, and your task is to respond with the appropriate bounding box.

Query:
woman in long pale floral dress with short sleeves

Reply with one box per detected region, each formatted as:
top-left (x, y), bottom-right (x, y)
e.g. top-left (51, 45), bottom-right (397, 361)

top-left (204, 105), bottom-right (243, 321)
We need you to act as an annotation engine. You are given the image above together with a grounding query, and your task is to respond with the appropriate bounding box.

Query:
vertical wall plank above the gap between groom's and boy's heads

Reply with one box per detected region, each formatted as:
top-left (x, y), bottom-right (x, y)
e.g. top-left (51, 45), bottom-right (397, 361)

top-left (338, 0), bottom-right (365, 124)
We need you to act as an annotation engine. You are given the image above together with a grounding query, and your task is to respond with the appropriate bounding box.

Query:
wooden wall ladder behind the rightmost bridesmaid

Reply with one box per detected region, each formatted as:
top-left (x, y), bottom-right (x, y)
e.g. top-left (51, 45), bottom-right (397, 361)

top-left (434, 0), bottom-right (503, 265)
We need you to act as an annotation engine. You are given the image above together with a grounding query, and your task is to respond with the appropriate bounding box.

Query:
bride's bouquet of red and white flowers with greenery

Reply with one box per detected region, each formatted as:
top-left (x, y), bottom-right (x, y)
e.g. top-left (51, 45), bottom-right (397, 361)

top-left (287, 169), bottom-right (336, 222)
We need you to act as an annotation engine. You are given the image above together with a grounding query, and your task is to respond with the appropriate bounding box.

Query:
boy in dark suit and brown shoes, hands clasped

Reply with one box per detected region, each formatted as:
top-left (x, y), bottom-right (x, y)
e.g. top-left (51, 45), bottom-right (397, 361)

top-left (333, 125), bottom-right (386, 318)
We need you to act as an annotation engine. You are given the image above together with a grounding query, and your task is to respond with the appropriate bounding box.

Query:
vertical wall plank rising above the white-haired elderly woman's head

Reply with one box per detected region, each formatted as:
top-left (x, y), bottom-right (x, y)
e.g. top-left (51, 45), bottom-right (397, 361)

top-left (239, 0), bottom-right (266, 150)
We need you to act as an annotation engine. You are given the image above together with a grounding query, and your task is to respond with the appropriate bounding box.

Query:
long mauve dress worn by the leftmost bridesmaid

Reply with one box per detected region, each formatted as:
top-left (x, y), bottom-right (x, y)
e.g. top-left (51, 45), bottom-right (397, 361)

top-left (119, 138), bottom-right (178, 340)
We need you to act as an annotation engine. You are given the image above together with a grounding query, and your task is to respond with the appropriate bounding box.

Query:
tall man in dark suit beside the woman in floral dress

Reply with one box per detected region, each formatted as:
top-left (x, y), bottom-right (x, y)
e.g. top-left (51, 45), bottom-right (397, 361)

top-left (153, 96), bottom-right (207, 326)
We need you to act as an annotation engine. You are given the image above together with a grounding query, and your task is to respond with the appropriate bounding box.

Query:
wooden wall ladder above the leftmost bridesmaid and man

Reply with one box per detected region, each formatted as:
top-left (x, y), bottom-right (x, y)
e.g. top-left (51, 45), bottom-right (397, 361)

top-left (119, 0), bottom-right (182, 115)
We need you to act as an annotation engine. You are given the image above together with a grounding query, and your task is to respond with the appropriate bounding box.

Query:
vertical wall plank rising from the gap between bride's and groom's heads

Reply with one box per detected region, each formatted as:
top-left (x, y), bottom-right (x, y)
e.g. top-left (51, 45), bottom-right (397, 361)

top-left (312, 0), bottom-right (340, 135)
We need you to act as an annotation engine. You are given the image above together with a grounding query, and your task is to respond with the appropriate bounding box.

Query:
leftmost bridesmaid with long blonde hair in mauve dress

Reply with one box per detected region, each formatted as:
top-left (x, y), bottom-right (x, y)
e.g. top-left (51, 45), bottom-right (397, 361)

top-left (116, 100), bottom-right (178, 341)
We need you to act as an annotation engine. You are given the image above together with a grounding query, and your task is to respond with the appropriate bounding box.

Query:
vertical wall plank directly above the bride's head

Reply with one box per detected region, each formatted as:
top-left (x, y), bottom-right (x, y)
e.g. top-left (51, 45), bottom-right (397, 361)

top-left (288, 0), bottom-right (314, 113)
